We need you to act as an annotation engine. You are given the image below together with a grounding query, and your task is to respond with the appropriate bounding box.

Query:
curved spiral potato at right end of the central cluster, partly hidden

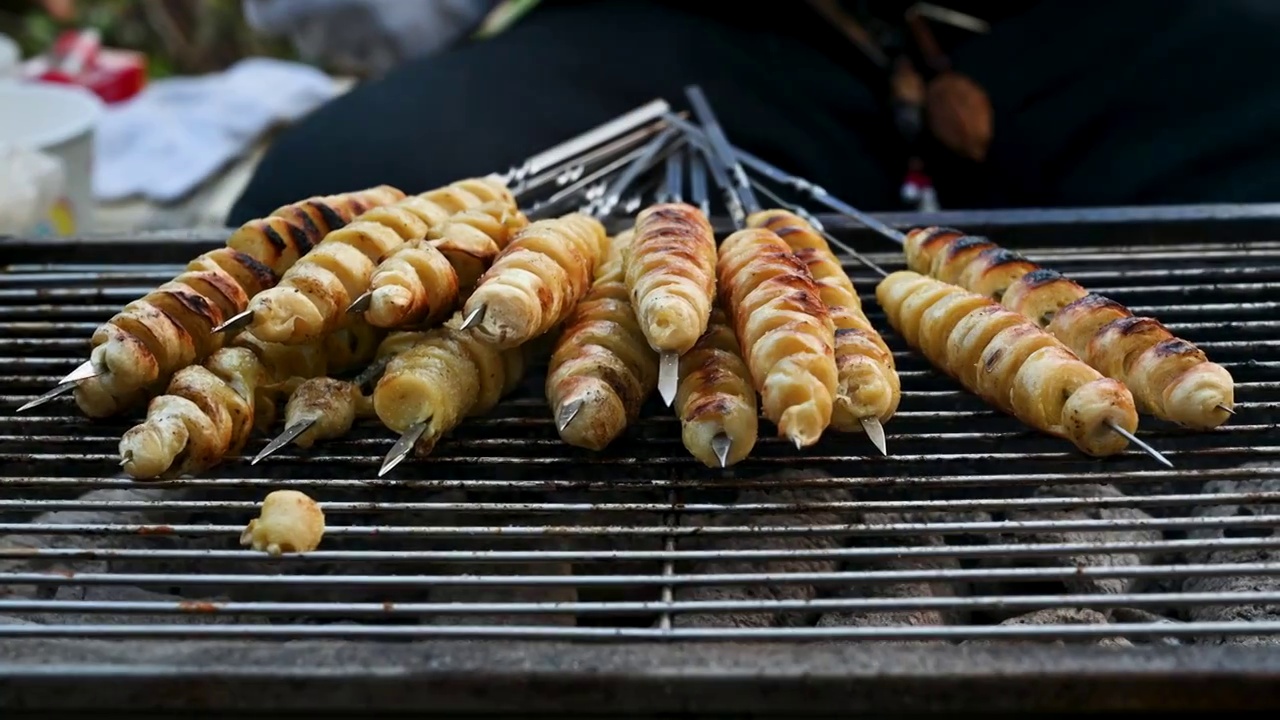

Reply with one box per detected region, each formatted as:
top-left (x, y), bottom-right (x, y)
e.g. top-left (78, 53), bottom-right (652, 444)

top-left (746, 210), bottom-right (902, 432)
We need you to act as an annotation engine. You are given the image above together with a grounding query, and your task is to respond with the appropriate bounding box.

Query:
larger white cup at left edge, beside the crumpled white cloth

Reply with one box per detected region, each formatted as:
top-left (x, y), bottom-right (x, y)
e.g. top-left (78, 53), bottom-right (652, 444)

top-left (0, 82), bottom-right (104, 236)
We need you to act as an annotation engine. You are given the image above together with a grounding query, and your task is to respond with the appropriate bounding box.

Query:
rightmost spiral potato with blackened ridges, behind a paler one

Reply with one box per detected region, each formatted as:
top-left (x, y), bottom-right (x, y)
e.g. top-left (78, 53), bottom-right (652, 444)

top-left (905, 228), bottom-right (1235, 430)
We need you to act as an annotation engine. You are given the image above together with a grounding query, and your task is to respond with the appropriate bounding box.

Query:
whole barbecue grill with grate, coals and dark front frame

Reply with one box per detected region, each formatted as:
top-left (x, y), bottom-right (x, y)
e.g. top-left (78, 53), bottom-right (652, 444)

top-left (0, 205), bottom-right (1280, 714)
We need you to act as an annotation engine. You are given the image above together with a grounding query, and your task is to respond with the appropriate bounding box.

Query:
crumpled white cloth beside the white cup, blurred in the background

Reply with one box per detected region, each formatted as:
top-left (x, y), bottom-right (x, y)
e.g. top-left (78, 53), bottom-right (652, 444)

top-left (93, 58), bottom-right (338, 202)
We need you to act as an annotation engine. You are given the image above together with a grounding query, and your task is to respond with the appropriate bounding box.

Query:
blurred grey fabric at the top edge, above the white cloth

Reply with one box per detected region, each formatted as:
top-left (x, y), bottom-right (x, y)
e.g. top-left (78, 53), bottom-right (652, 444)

top-left (243, 0), bottom-right (498, 74)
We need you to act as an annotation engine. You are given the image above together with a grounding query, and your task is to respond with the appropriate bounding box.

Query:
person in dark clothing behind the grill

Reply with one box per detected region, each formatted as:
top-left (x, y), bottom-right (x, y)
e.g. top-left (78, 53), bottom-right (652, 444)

top-left (228, 0), bottom-right (1280, 224)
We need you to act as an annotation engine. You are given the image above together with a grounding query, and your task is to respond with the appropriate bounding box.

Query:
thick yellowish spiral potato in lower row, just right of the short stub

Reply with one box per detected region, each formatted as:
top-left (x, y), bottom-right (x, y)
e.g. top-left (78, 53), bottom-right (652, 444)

top-left (374, 314), bottom-right (526, 455)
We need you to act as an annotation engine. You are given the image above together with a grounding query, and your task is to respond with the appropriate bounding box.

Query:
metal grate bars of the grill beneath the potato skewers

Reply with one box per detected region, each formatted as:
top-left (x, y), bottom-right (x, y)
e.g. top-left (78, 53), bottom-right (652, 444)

top-left (0, 204), bottom-right (1280, 646)
